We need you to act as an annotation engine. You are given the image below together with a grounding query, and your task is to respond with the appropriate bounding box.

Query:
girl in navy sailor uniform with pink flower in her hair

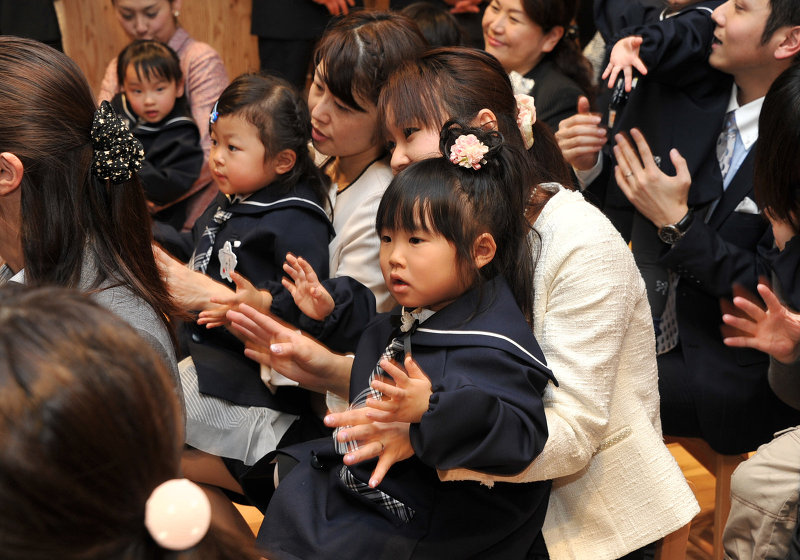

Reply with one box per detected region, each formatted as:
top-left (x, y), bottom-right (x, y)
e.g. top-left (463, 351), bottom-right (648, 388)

top-left (250, 123), bottom-right (555, 560)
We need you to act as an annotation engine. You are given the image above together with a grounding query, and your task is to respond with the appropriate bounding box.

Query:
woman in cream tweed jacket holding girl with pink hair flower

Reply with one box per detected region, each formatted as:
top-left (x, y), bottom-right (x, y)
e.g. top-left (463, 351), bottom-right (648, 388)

top-left (230, 49), bottom-right (698, 559)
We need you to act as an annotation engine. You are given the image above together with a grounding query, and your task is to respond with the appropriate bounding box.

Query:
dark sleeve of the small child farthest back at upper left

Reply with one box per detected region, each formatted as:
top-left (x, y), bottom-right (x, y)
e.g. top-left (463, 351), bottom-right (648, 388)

top-left (139, 121), bottom-right (203, 206)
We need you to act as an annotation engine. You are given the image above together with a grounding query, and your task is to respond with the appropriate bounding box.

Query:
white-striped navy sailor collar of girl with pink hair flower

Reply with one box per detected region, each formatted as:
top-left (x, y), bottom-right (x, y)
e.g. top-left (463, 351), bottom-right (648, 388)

top-left (391, 276), bottom-right (558, 386)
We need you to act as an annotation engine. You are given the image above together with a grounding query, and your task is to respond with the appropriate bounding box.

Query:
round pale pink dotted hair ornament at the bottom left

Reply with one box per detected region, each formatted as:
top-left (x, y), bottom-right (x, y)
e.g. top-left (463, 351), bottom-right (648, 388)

top-left (144, 478), bottom-right (211, 551)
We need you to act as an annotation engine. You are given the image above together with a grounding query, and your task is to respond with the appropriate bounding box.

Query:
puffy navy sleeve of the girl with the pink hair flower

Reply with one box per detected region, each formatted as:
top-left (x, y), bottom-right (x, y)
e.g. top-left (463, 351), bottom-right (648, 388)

top-left (410, 347), bottom-right (548, 475)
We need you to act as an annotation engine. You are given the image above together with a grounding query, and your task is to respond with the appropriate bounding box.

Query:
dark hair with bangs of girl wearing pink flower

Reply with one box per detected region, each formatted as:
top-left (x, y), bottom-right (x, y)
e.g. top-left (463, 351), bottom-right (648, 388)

top-left (375, 120), bottom-right (533, 324)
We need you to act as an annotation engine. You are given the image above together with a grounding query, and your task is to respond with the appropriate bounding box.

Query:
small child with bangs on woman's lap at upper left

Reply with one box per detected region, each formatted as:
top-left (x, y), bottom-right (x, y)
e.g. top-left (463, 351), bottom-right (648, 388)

top-left (111, 40), bottom-right (203, 230)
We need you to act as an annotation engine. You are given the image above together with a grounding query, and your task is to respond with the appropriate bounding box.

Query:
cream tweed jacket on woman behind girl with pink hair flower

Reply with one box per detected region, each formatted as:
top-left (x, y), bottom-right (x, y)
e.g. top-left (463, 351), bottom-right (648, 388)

top-left (440, 186), bottom-right (700, 560)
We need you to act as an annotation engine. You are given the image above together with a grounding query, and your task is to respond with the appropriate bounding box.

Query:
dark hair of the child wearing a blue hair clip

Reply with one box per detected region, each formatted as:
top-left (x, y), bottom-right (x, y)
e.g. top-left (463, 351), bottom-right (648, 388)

top-left (209, 74), bottom-right (328, 207)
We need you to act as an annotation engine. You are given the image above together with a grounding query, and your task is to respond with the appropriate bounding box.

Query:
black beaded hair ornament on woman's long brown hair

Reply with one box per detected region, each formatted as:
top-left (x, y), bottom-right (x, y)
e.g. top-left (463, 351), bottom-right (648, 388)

top-left (91, 101), bottom-right (144, 185)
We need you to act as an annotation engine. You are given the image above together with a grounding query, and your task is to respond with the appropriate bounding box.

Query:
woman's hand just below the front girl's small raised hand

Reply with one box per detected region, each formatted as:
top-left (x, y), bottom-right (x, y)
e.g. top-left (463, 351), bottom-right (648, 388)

top-left (325, 407), bottom-right (414, 488)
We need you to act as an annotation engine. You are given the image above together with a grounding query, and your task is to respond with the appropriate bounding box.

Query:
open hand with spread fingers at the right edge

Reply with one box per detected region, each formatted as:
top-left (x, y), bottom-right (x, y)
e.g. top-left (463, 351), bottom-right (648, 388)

top-left (722, 282), bottom-right (800, 364)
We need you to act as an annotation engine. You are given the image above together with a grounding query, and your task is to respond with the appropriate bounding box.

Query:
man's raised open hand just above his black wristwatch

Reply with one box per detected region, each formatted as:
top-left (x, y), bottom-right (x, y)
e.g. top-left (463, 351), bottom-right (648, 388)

top-left (614, 128), bottom-right (692, 227)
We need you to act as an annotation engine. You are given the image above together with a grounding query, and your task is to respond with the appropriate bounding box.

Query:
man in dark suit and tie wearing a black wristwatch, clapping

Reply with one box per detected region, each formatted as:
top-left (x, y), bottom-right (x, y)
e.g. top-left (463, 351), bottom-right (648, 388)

top-left (557, 0), bottom-right (800, 453)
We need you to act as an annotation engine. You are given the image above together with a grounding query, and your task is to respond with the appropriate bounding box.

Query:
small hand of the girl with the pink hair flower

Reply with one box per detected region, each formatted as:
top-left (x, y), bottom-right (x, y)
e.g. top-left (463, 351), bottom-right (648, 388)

top-left (367, 356), bottom-right (432, 423)
